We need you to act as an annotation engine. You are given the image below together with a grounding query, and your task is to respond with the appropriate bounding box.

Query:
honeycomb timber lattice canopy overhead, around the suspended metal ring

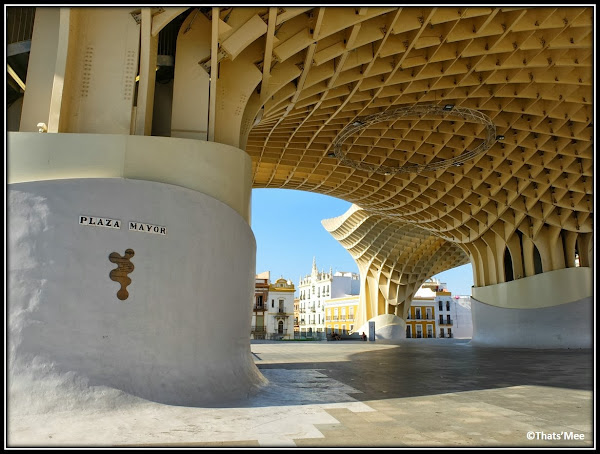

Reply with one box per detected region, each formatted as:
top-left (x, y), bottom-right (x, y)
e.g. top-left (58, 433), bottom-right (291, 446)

top-left (234, 7), bottom-right (593, 243)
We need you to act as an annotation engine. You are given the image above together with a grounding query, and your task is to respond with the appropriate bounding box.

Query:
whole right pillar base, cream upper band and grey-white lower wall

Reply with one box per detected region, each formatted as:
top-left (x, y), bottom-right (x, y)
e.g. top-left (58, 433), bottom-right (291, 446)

top-left (471, 267), bottom-right (594, 348)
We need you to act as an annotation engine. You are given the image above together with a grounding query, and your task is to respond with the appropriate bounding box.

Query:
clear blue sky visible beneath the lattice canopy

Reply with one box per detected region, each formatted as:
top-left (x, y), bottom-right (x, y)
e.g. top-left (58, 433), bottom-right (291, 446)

top-left (252, 189), bottom-right (473, 295)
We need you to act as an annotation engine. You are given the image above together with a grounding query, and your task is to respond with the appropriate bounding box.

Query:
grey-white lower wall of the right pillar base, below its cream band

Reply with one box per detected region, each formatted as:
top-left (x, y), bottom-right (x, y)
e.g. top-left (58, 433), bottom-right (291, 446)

top-left (471, 297), bottom-right (594, 348)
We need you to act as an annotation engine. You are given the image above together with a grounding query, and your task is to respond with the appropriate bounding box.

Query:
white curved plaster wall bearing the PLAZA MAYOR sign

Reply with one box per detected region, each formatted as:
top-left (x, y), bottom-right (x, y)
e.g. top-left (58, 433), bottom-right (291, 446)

top-left (7, 176), bottom-right (264, 406)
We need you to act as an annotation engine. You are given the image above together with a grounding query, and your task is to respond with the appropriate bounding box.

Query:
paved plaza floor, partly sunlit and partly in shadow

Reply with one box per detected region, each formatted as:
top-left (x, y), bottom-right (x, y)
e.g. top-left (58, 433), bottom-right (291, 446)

top-left (8, 339), bottom-right (595, 449)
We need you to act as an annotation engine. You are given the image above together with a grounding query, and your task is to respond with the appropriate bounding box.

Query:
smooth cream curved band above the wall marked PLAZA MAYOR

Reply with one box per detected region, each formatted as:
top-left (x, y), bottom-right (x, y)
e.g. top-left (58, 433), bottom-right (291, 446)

top-left (7, 132), bottom-right (252, 223)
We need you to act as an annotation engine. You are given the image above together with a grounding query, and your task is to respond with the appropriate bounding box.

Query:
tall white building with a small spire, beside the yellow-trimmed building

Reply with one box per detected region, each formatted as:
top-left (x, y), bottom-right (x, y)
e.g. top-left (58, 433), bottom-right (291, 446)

top-left (298, 258), bottom-right (360, 337)
